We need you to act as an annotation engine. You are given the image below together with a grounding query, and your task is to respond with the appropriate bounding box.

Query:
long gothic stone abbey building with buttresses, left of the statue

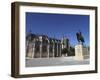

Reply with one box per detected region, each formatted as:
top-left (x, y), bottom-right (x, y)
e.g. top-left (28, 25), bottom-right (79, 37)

top-left (26, 33), bottom-right (70, 58)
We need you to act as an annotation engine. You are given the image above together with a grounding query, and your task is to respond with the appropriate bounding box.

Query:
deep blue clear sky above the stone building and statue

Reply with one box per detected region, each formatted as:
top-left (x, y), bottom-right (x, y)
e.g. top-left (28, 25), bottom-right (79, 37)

top-left (26, 12), bottom-right (89, 45)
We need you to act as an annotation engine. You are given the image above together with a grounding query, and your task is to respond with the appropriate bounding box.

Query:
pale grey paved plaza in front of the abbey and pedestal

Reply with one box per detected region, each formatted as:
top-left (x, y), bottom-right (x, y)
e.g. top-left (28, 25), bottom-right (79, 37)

top-left (26, 57), bottom-right (89, 67)
